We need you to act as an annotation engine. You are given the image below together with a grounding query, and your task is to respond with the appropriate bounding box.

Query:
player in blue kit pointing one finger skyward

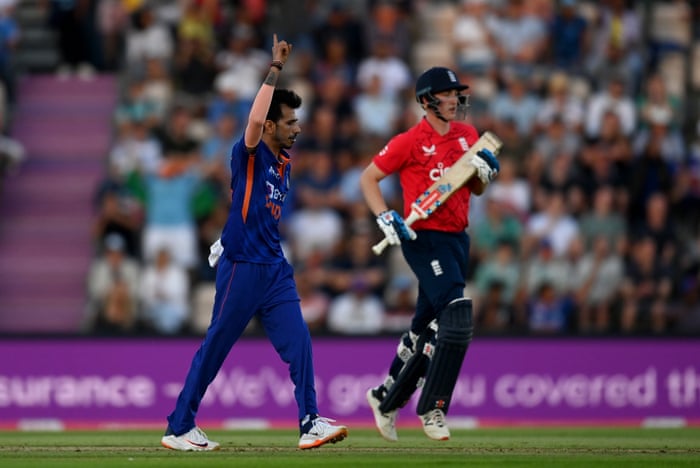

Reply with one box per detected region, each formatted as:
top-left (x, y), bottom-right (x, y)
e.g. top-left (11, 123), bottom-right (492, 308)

top-left (161, 35), bottom-right (348, 451)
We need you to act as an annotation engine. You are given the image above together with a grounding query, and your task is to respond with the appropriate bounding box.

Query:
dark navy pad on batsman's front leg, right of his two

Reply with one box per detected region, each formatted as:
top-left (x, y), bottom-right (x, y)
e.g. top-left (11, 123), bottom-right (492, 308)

top-left (416, 298), bottom-right (473, 414)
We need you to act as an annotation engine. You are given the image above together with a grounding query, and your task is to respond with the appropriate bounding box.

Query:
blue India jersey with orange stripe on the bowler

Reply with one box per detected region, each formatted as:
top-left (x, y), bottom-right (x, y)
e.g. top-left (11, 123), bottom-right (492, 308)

top-left (221, 138), bottom-right (291, 264)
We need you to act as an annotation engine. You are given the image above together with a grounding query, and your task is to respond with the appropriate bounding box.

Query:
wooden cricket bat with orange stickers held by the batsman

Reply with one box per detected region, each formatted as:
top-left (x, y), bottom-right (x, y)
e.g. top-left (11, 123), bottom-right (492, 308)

top-left (372, 132), bottom-right (503, 255)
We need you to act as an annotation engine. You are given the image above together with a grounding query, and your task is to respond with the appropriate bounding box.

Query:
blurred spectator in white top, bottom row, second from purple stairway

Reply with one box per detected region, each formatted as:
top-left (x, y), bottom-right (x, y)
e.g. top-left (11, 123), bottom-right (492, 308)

top-left (139, 248), bottom-right (190, 335)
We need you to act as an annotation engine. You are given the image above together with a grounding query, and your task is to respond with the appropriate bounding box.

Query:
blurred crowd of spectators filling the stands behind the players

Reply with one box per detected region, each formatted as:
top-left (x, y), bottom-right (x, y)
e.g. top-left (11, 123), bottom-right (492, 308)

top-left (0, 0), bottom-right (700, 335)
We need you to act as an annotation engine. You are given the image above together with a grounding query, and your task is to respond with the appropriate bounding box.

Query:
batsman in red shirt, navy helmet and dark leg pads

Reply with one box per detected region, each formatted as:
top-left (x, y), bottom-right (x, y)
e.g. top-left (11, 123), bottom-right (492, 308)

top-left (360, 67), bottom-right (500, 441)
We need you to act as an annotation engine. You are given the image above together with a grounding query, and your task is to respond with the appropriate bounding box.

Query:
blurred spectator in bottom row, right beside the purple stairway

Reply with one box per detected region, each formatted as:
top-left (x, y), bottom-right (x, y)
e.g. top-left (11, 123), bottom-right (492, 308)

top-left (84, 233), bottom-right (141, 335)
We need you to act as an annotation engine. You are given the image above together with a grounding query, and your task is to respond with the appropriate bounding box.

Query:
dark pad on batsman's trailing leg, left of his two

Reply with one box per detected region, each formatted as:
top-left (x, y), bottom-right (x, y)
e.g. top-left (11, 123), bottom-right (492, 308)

top-left (379, 320), bottom-right (437, 413)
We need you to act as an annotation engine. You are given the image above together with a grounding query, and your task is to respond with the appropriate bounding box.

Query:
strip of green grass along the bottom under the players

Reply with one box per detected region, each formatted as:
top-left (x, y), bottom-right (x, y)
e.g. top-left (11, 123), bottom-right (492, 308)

top-left (0, 427), bottom-right (700, 468)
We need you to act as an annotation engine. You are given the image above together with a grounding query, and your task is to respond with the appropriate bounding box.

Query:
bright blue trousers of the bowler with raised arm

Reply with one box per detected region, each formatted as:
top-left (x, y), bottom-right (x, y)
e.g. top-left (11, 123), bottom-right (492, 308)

top-left (168, 256), bottom-right (318, 435)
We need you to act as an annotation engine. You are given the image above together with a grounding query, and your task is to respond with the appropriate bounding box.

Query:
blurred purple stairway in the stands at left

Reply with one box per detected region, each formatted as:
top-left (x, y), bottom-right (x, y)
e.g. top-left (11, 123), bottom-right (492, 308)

top-left (0, 75), bottom-right (117, 335)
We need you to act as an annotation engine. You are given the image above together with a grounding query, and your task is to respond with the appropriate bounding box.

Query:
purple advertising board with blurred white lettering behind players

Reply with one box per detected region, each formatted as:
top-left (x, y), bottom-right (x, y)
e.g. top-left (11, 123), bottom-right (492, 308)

top-left (0, 338), bottom-right (700, 427)
